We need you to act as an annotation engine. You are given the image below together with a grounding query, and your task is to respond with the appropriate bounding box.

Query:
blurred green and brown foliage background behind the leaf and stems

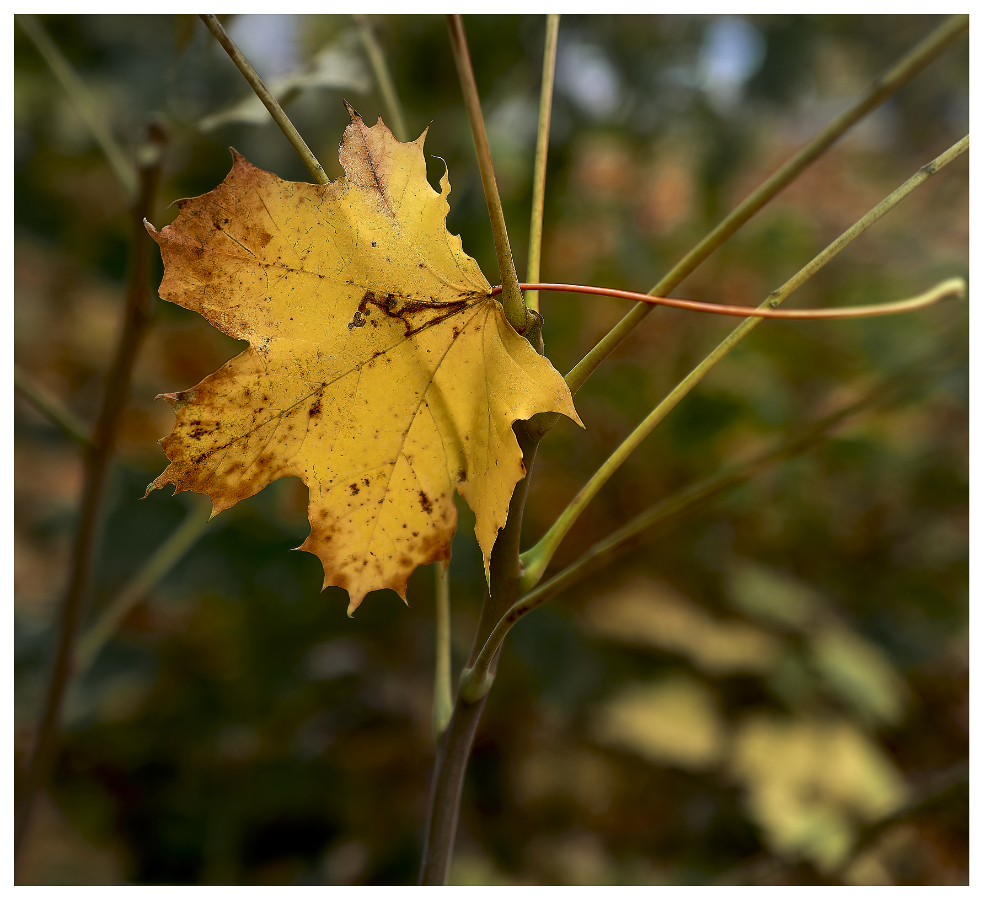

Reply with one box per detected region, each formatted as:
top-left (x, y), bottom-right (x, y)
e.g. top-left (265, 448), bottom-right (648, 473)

top-left (14, 15), bottom-right (969, 884)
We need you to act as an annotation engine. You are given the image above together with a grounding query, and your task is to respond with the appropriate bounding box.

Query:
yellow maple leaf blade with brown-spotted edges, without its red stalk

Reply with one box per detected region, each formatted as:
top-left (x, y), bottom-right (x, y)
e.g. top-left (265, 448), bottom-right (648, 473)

top-left (147, 105), bottom-right (580, 614)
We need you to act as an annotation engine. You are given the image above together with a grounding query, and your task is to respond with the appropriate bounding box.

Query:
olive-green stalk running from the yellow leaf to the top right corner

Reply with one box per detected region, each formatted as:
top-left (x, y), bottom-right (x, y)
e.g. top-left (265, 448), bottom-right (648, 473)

top-left (560, 16), bottom-right (969, 400)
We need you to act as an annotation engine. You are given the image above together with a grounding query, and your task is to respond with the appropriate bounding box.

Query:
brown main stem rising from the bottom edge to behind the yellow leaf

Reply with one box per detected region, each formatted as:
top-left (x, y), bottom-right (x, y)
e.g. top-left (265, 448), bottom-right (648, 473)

top-left (420, 425), bottom-right (539, 885)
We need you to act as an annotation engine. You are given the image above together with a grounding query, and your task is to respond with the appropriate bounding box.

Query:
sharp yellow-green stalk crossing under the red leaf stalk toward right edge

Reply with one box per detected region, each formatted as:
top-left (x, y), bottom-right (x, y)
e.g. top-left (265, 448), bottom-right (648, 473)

top-left (521, 136), bottom-right (969, 590)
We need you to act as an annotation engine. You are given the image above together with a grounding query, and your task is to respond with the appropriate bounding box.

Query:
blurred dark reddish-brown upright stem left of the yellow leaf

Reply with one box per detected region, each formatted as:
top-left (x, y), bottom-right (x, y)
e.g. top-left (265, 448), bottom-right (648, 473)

top-left (14, 126), bottom-right (166, 872)
